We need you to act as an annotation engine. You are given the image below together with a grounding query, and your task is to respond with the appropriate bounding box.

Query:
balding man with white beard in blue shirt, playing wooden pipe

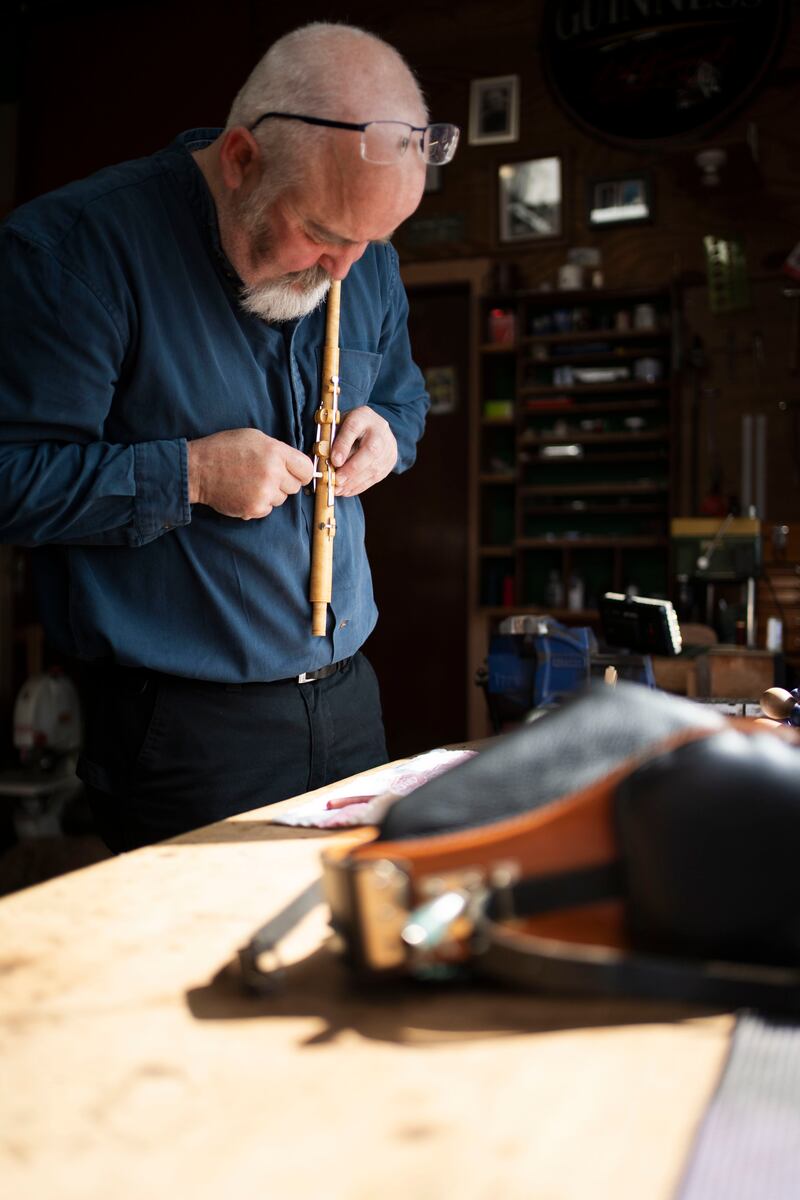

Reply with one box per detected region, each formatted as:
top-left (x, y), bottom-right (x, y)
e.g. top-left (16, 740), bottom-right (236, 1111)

top-left (0, 24), bottom-right (458, 851)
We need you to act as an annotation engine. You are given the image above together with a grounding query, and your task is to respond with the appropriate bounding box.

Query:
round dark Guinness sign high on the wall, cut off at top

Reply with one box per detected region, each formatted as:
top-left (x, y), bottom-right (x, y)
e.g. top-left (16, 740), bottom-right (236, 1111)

top-left (542, 0), bottom-right (787, 146)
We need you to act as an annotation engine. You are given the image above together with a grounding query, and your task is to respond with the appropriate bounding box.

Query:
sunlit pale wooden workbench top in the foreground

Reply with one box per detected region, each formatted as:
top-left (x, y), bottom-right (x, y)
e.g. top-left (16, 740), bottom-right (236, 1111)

top-left (0, 768), bottom-right (733, 1200)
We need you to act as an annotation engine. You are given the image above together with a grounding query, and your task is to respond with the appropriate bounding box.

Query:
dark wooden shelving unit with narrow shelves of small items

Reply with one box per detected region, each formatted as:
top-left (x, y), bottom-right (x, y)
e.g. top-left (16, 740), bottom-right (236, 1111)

top-left (474, 288), bottom-right (676, 624)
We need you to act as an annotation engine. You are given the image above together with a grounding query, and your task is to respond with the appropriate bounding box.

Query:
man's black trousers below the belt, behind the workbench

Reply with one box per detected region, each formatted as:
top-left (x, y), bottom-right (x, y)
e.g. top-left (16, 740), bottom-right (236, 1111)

top-left (78, 654), bottom-right (386, 852)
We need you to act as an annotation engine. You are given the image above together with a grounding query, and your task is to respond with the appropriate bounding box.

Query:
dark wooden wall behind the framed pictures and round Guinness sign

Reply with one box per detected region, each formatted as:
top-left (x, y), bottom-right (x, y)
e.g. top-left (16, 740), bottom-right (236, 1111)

top-left (376, 0), bottom-right (800, 523)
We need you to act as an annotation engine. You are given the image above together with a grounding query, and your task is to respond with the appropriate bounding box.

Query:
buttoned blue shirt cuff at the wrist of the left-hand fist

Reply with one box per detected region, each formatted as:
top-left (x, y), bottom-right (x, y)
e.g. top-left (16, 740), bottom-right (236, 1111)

top-left (133, 438), bottom-right (192, 545)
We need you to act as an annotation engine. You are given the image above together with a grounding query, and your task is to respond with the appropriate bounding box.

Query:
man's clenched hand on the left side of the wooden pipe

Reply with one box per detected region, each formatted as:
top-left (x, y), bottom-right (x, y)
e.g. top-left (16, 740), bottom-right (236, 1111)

top-left (188, 430), bottom-right (313, 521)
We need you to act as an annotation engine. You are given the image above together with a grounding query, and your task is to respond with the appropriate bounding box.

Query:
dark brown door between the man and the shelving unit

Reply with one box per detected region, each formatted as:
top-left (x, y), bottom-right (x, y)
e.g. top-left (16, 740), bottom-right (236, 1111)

top-left (363, 282), bottom-right (470, 758)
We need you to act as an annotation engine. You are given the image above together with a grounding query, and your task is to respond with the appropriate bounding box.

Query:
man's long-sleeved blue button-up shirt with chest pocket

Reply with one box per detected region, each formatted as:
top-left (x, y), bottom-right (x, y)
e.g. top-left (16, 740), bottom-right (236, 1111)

top-left (0, 130), bottom-right (428, 683)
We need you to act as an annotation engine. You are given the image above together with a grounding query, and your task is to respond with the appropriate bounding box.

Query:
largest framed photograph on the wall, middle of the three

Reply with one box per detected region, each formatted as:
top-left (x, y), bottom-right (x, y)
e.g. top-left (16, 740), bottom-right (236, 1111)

top-left (498, 156), bottom-right (563, 241)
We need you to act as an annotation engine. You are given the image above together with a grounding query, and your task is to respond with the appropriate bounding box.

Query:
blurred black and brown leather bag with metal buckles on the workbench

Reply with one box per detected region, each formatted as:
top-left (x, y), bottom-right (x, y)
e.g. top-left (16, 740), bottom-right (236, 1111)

top-left (324, 683), bottom-right (800, 1010)
